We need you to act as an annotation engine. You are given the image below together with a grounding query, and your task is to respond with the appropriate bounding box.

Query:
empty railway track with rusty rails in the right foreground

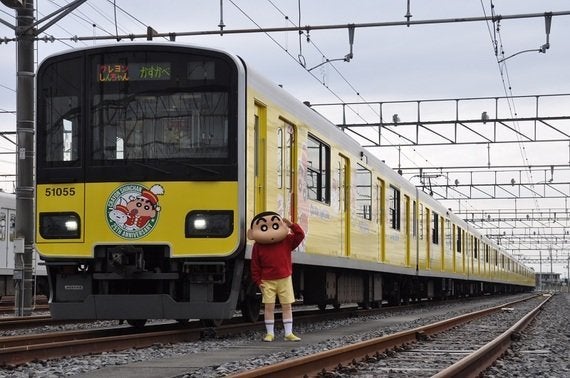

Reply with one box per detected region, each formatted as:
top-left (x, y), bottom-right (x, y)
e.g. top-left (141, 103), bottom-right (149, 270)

top-left (232, 296), bottom-right (550, 378)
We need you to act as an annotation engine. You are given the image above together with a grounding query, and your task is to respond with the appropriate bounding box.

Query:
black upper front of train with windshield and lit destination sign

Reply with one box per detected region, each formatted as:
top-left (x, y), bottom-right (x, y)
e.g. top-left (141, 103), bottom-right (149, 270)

top-left (38, 48), bottom-right (237, 179)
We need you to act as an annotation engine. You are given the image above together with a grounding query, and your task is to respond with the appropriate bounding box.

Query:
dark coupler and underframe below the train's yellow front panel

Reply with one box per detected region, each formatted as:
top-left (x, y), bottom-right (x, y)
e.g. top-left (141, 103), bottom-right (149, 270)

top-left (46, 245), bottom-right (244, 325)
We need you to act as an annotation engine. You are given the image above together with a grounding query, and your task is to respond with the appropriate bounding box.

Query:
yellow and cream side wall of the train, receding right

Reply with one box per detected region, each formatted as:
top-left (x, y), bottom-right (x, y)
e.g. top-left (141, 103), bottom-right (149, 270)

top-left (246, 77), bottom-right (531, 290)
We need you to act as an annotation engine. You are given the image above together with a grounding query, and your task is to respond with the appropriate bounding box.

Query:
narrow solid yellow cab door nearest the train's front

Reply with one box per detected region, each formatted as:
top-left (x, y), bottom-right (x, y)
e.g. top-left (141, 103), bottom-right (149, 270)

top-left (254, 103), bottom-right (267, 214)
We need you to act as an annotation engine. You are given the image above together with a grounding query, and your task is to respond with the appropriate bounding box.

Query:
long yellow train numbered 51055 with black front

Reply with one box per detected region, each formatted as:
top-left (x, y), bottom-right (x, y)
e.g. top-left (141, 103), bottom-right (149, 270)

top-left (36, 44), bottom-right (534, 325)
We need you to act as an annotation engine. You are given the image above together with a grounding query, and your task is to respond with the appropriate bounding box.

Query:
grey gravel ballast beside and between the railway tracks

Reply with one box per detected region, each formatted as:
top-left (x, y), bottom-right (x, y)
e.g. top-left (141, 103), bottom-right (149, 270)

top-left (0, 293), bottom-right (570, 378)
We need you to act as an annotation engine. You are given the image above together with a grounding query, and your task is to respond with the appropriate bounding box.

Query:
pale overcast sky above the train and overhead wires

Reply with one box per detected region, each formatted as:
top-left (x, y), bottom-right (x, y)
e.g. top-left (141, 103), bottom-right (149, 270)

top-left (0, 0), bottom-right (570, 276)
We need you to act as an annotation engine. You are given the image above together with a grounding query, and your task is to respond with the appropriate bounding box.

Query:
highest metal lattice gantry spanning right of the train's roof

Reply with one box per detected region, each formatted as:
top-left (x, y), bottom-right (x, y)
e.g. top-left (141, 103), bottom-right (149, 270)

top-left (311, 93), bottom-right (570, 149)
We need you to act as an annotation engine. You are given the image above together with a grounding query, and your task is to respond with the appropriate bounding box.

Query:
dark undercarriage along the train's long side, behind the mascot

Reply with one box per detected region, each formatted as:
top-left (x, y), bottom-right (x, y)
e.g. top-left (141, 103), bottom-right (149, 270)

top-left (240, 265), bottom-right (532, 321)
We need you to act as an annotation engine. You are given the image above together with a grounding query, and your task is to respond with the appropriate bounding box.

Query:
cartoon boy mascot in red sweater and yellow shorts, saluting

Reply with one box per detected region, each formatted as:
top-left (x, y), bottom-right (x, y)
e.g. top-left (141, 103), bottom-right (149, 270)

top-left (247, 211), bottom-right (305, 341)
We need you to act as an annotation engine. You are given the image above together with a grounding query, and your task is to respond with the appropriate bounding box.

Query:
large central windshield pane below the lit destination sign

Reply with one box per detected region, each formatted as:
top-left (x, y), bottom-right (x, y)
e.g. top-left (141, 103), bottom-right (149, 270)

top-left (91, 92), bottom-right (228, 160)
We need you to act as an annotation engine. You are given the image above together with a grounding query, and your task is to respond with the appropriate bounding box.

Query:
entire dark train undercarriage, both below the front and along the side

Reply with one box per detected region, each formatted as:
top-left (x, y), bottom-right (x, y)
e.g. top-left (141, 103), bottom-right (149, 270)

top-left (42, 246), bottom-right (528, 326)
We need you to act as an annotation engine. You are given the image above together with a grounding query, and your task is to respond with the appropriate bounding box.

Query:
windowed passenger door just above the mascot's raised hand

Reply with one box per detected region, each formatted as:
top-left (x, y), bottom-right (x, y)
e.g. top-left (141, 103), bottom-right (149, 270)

top-left (277, 121), bottom-right (297, 222)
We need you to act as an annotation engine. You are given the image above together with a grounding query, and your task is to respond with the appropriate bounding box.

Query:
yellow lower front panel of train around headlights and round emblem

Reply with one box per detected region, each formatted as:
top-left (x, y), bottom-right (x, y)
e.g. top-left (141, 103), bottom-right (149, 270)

top-left (36, 182), bottom-right (240, 258)
